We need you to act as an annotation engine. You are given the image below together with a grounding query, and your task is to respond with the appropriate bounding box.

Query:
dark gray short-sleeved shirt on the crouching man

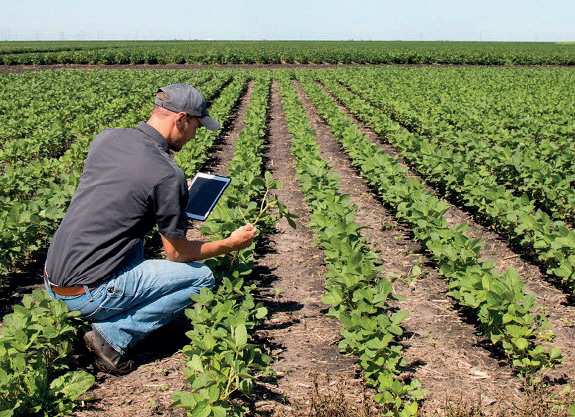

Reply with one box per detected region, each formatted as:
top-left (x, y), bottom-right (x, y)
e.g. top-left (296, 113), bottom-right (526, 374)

top-left (46, 123), bottom-right (188, 287)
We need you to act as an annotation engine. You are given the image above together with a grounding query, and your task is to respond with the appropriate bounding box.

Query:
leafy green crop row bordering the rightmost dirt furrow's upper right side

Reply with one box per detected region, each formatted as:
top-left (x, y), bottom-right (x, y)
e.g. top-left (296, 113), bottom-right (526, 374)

top-left (318, 70), bottom-right (575, 290)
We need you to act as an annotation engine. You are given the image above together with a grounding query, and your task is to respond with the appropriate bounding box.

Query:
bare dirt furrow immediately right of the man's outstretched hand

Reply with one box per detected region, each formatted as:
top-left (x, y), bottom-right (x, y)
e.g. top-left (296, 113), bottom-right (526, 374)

top-left (253, 82), bottom-right (362, 412)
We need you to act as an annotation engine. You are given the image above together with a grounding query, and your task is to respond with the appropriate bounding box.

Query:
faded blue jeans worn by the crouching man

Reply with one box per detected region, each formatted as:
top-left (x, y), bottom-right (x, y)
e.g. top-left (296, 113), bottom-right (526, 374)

top-left (47, 242), bottom-right (214, 355)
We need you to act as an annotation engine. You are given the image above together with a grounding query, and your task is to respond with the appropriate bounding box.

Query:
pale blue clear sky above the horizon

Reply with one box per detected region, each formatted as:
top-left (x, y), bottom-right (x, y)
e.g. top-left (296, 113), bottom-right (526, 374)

top-left (0, 0), bottom-right (575, 41)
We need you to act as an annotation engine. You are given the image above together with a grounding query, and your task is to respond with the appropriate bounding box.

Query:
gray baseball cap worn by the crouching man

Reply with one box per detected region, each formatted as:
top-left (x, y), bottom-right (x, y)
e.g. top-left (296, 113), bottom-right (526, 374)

top-left (155, 83), bottom-right (220, 130)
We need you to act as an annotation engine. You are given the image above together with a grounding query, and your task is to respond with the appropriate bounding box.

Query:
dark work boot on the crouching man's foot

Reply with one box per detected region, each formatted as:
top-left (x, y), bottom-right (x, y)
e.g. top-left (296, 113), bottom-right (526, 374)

top-left (84, 326), bottom-right (136, 375)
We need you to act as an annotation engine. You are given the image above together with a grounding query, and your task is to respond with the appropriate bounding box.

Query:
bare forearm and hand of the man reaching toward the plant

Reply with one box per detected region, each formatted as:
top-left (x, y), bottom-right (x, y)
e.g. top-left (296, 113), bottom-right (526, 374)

top-left (161, 224), bottom-right (257, 262)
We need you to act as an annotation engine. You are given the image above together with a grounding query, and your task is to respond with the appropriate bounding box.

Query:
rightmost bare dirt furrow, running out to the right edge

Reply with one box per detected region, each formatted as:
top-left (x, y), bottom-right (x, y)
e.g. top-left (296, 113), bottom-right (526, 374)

top-left (316, 79), bottom-right (575, 386)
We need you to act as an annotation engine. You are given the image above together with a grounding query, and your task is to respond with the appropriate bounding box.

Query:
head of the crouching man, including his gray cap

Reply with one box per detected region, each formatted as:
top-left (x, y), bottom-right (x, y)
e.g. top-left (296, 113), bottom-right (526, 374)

top-left (148, 83), bottom-right (220, 151)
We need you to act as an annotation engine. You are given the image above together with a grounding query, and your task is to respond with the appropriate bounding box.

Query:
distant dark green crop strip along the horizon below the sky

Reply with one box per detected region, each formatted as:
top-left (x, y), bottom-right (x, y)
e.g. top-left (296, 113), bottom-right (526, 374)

top-left (0, 41), bottom-right (575, 65)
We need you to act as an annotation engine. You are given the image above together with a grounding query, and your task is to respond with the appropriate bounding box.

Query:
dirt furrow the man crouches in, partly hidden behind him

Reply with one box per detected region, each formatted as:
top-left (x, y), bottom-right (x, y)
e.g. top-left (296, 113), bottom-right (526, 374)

top-left (74, 82), bottom-right (253, 417)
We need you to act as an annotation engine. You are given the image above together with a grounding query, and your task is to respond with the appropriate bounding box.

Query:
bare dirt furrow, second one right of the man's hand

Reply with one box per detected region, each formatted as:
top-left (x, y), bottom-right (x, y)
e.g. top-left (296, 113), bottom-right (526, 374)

top-left (296, 79), bottom-right (532, 412)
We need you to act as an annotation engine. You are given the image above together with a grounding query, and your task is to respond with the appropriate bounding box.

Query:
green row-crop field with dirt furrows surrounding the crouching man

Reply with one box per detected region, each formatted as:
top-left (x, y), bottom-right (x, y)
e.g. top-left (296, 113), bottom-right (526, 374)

top-left (0, 66), bottom-right (575, 417)
